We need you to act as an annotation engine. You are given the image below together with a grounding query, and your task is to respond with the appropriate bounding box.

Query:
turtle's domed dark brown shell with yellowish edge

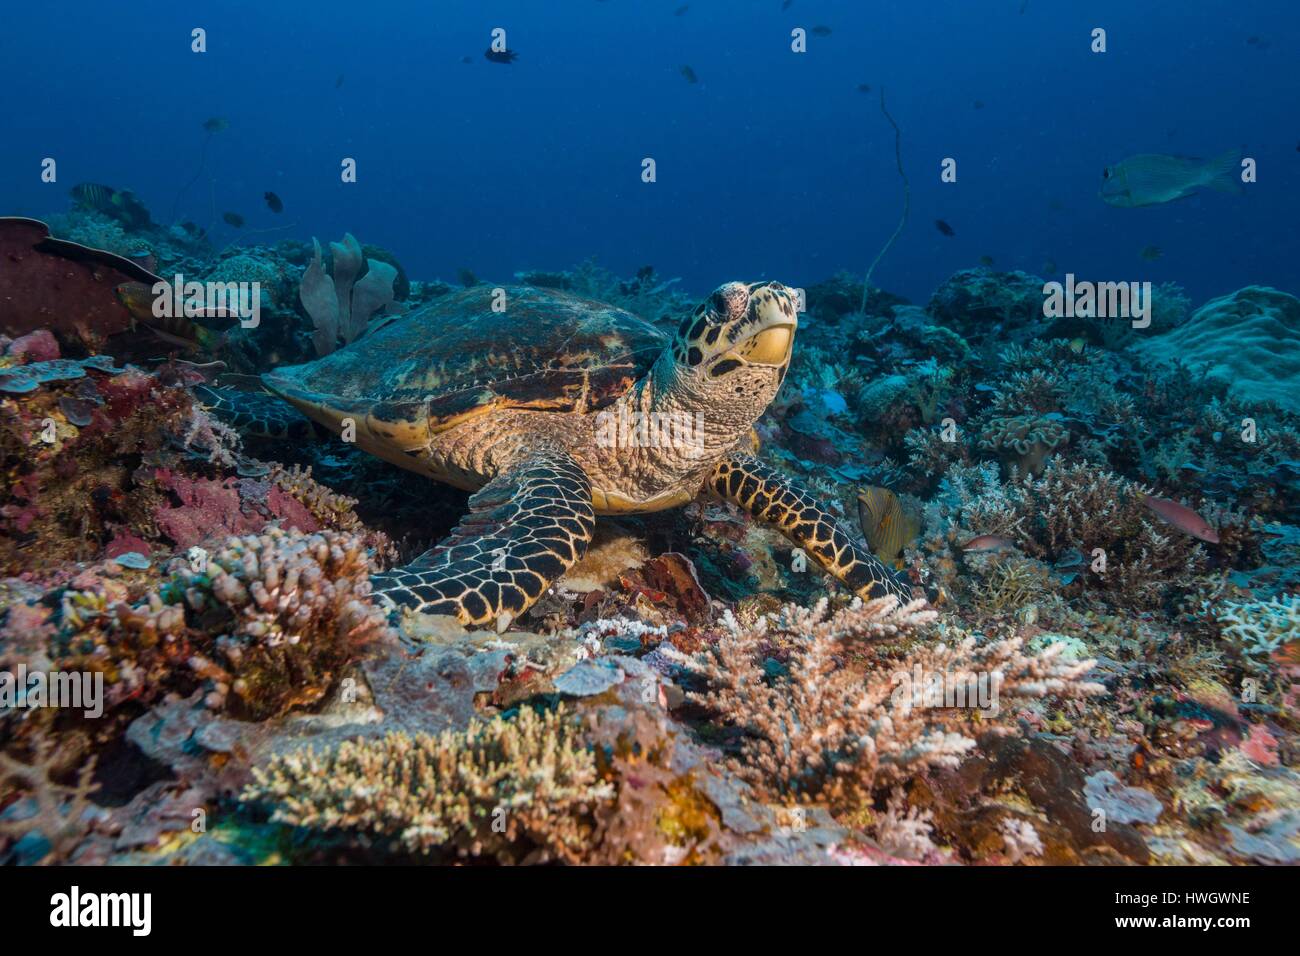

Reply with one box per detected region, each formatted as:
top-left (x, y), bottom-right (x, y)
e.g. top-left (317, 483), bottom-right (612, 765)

top-left (264, 285), bottom-right (668, 450)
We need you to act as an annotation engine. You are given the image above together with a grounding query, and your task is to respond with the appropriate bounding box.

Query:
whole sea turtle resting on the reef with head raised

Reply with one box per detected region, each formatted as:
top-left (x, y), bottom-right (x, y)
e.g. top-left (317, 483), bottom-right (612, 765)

top-left (239, 282), bottom-right (911, 628)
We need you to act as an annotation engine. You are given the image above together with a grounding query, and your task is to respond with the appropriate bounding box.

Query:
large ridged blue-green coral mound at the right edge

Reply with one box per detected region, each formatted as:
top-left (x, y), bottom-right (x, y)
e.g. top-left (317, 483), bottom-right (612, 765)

top-left (1135, 286), bottom-right (1300, 412)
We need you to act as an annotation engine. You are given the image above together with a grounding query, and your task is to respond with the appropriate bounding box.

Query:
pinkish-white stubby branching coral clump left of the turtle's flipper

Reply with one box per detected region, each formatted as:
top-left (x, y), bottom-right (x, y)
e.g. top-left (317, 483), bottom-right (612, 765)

top-left (51, 527), bottom-right (387, 719)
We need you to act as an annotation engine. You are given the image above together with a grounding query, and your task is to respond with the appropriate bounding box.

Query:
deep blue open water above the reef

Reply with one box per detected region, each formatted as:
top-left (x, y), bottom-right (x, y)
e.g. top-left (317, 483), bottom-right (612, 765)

top-left (0, 0), bottom-right (1300, 304)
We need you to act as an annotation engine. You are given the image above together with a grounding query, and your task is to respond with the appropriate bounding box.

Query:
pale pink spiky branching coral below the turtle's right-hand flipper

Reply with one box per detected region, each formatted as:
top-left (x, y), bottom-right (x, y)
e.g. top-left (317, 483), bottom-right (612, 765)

top-left (660, 598), bottom-right (1102, 806)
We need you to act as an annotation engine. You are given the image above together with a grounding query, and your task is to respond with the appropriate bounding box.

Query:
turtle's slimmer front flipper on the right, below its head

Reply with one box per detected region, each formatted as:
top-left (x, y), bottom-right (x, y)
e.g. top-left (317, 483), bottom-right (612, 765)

top-left (709, 454), bottom-right (913, 602)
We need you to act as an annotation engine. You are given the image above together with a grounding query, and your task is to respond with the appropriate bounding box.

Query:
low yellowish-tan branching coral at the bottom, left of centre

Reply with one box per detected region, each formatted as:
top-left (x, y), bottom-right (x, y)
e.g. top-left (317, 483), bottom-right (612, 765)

top-left (242, 708), bottom-right (614, 861)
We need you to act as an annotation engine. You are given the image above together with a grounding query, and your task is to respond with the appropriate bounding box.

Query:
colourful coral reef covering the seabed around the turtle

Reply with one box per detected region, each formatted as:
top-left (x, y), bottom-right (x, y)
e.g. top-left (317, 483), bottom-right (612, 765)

top-left (0, 231), bottom-right (1300, 865)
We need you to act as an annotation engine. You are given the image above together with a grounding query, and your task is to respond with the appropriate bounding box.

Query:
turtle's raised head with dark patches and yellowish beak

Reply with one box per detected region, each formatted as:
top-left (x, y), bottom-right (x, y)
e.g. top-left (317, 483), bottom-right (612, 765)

top-left (672, 282), bottom-right (800, 408)
